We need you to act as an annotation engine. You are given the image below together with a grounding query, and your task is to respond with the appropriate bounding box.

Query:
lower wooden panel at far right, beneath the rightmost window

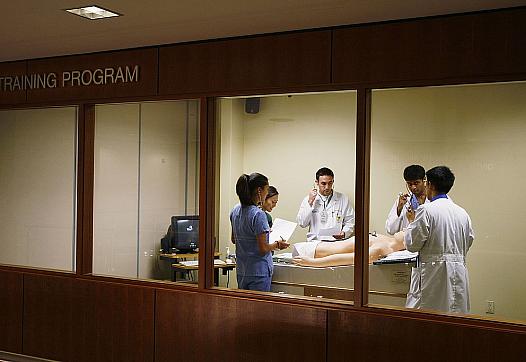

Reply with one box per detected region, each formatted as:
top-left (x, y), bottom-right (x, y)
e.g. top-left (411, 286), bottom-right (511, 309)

top-left (327, 311), bottom-right (526, 362)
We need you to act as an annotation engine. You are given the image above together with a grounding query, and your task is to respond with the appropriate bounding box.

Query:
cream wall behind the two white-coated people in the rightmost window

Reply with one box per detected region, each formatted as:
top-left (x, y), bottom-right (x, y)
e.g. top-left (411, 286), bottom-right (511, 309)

top-left (371, 83), bottom-right (526, 320)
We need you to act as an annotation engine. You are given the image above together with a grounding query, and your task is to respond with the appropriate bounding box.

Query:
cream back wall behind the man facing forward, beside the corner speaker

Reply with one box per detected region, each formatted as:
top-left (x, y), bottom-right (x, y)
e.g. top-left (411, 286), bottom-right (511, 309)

top-left (243, 92), bottom-right (356, 235)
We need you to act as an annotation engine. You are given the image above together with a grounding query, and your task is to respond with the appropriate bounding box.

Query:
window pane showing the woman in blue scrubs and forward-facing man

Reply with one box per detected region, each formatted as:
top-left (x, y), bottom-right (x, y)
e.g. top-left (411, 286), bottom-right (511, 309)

top-left (216, 92), bottom-right (356, 301)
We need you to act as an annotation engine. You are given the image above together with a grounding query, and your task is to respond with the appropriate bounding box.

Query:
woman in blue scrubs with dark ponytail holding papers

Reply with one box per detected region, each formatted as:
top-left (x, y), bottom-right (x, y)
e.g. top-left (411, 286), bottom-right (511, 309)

top-left (230, 172), bottom-right (289, 292)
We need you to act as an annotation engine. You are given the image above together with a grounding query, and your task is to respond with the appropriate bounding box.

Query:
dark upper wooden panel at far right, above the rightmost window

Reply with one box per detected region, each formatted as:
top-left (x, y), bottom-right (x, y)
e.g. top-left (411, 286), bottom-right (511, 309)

top-left (333, 9), bottom-right (526, 84)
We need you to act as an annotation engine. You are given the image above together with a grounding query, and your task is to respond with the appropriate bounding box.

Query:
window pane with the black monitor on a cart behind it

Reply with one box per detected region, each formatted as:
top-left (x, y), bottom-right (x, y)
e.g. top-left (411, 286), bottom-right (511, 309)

top-left (93, 100), bottom-right (199, 283)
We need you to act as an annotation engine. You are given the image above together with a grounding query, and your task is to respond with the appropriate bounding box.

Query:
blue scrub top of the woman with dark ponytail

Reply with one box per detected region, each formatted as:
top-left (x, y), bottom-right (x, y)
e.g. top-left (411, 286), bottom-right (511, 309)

top-left (230, 204), bottom-right (273, 276)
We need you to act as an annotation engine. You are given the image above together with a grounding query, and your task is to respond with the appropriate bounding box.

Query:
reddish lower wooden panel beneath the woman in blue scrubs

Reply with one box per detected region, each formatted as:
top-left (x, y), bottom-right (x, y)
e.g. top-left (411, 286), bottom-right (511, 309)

top-left (155, 290), bottom-right (327, 362)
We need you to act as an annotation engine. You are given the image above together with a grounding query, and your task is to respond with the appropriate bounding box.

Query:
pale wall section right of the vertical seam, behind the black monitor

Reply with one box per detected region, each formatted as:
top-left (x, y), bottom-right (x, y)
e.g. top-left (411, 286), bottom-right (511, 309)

top-left (139, 101), bottom-right (199, 278)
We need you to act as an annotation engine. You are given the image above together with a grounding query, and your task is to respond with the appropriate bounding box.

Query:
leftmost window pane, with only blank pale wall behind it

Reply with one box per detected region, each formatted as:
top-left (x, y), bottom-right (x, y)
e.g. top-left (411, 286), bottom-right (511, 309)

top-left (0, 107), bottom-right (77, 271)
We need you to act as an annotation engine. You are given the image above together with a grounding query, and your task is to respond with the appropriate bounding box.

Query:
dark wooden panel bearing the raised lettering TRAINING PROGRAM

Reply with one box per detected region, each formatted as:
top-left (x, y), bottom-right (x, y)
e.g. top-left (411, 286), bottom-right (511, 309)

top-left (25, 48), bottom-right (158, 103)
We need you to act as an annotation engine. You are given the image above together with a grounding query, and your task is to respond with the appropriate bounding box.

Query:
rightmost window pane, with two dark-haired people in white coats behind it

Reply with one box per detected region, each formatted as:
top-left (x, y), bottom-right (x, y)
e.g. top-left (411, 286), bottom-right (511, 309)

top-left (369, 83), bottom-right (526, 321)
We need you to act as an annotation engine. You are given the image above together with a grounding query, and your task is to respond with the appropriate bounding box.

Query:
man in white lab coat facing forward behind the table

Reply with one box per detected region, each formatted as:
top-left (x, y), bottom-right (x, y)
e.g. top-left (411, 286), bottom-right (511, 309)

top-left (297, 167), bottom-right (354, 241)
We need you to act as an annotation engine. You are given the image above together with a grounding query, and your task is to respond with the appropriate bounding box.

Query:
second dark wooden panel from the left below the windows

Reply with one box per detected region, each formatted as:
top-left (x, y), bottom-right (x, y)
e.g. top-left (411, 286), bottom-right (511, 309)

top-left (23, 275), bottom-right (154, 362)
